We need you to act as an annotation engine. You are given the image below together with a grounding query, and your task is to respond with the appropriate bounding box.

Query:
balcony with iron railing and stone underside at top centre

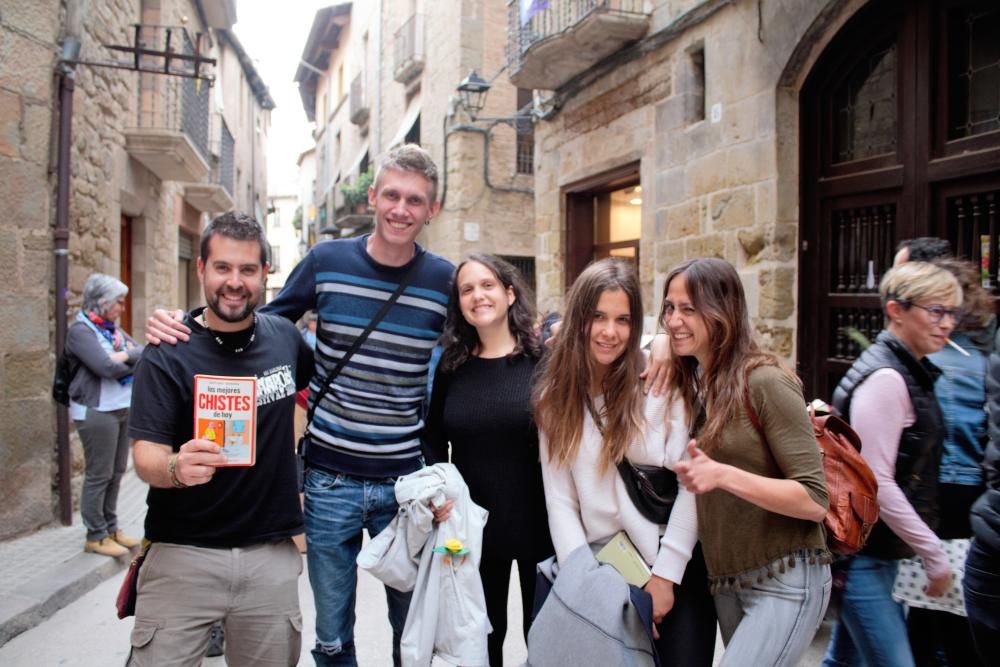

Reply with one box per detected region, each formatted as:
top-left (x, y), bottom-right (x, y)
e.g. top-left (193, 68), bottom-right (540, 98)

top-left (507, 0), bottom-right (650, 89)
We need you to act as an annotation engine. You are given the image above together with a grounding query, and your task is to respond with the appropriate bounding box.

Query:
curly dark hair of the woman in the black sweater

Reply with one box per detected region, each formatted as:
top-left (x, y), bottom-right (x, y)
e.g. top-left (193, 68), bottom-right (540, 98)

top-left (441, 254), bottom-right (542, 373)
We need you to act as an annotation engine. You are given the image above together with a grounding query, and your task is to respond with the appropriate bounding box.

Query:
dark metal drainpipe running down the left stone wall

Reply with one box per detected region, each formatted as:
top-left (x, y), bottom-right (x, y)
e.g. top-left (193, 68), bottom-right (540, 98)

top-left (52, 0), bottom-right (82, 526)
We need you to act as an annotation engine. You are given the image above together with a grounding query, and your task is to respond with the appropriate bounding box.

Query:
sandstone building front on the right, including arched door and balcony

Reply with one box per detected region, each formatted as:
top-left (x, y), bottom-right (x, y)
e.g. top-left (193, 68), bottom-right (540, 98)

top-left (520, 0), bottom-right (1000, 398)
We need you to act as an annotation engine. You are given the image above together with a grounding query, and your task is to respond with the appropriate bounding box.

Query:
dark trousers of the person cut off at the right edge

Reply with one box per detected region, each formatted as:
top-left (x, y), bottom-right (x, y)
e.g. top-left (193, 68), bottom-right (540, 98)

top-left (962, 538), bottom-right (1000, 665)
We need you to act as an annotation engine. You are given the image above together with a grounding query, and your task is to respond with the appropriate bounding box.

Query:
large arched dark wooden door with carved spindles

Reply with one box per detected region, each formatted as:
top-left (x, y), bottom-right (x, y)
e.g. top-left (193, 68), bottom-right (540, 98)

top-left (798, 0), bottom-right (1000, 399)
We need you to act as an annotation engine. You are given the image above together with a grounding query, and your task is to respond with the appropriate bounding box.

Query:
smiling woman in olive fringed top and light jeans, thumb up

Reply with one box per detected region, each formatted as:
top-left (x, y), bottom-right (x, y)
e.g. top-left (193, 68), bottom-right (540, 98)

top-left (661, 258), bottom-right (831, 667)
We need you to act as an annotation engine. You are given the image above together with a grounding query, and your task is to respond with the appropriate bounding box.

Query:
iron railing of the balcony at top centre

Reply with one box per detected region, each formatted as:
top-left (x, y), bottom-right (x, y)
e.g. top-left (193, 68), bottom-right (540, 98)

top-left (507, 0), bottom-right (648, 71)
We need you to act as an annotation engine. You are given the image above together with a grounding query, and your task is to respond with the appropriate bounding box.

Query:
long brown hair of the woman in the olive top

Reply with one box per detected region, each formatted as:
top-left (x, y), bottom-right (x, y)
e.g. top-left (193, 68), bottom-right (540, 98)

top-left (660, 257), bottom-right (798, 452)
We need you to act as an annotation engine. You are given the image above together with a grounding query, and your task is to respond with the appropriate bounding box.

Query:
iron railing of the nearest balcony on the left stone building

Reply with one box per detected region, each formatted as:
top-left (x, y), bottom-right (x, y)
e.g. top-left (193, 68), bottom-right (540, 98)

top-left (136, 26), bottom-right (210, 160)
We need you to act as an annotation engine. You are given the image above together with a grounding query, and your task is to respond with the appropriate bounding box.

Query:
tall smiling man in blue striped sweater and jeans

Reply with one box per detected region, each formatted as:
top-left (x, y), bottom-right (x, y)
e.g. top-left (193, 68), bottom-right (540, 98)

top-left (147, 145), bottom-right (454, 666)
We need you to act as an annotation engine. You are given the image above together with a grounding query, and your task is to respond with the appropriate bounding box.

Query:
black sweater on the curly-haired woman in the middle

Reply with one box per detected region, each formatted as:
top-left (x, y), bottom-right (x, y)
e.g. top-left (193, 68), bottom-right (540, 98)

top-left (424, 356), bottom-right (552, 560)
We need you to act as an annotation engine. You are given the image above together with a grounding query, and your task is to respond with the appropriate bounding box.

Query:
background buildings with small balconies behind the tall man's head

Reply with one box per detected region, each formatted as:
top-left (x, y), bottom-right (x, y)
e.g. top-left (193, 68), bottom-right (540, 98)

top-left (296, 0), bottom-right (535, 281)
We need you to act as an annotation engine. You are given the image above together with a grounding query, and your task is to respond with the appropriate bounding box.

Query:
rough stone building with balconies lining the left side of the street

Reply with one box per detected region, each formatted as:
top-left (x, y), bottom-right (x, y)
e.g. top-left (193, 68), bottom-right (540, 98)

top-left (0, 0), bottom-right (273, 538)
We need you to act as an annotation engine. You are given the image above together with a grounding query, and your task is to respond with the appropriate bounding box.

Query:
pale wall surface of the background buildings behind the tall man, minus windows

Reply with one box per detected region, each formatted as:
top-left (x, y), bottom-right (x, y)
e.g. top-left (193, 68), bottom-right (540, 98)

top-left (304, 0), bottom-right (535, 280)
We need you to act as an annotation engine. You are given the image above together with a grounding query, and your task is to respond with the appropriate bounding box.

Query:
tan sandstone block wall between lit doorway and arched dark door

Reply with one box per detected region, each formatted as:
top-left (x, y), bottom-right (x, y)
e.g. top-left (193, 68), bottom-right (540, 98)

top-left (535, 0), bottom-right (844, 359)
